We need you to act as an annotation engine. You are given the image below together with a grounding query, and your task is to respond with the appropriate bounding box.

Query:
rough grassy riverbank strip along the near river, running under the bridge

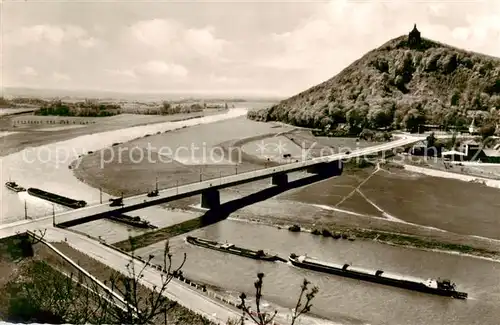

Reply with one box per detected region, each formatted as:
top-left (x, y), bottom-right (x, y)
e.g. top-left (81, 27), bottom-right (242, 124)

top-left (112, 187), bottom-right (500, 262)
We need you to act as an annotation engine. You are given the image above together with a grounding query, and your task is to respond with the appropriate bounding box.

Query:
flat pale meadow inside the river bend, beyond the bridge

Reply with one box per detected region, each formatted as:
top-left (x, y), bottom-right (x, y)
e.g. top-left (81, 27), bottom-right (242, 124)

top-left (73, 116), bottom-right (290, 196)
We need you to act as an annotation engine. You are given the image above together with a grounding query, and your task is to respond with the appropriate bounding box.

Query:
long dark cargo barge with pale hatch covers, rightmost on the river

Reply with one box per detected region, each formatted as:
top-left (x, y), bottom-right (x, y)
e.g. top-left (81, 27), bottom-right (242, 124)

top-left (289, 254), bottom-right (468, 299)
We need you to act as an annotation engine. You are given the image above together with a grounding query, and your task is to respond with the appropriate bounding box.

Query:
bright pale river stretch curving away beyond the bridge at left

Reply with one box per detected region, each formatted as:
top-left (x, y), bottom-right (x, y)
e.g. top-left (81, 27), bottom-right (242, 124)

top-left (0, 109), bottom-right (246, 223)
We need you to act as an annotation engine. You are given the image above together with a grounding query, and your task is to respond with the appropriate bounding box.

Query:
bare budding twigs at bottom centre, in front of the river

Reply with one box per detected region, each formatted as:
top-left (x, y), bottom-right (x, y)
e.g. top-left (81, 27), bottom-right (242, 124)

top-left (232, 273), bottom-right (319, 325)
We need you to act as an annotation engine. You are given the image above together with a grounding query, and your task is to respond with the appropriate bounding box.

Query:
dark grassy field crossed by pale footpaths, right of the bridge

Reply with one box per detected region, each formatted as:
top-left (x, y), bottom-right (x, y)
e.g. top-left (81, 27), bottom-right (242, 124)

top-left (278, 165), bottom-right (500, 238)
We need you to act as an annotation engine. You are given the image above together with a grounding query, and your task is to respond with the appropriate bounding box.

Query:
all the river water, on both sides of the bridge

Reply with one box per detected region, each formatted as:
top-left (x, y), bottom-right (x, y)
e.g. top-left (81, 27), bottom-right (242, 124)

top-left (0, 109), bottom-right (500, 325)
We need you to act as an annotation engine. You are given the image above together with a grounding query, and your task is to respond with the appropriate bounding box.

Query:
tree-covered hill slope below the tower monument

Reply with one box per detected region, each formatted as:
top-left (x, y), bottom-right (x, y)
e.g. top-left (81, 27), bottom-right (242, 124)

top-left (248, 36), bottom-right (500, 135)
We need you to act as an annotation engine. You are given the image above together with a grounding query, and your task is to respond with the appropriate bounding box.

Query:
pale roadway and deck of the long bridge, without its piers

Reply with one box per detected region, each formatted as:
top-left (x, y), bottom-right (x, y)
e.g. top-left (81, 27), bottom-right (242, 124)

top-left (0, 136), bottom-right (422, 238)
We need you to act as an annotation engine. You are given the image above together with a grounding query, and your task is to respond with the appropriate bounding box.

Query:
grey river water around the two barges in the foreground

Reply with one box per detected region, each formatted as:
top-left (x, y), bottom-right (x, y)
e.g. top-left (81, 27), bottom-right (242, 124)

top-left (135, 220), bottom-right (500, 325)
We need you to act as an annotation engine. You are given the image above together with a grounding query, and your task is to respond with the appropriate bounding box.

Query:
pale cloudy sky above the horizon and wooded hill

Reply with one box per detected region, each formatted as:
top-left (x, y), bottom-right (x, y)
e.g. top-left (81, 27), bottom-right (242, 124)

top-left (0, 0), bottom-right (500, 96)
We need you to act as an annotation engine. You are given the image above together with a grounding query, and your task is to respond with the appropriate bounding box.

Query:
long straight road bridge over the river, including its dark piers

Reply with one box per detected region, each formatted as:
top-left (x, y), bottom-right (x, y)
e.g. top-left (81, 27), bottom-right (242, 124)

top-left (0, 135), bottom-right (422, 238)
